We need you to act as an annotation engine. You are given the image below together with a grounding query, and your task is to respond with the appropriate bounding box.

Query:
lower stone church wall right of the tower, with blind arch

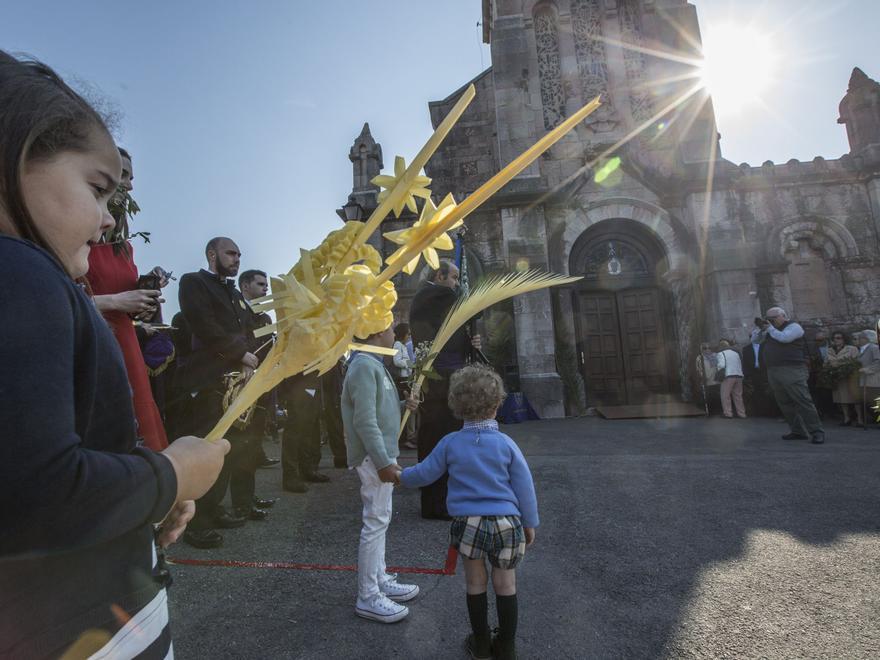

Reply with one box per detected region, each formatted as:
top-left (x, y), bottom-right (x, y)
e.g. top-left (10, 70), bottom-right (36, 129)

top-left (687, 158), bottom-right (880, 343)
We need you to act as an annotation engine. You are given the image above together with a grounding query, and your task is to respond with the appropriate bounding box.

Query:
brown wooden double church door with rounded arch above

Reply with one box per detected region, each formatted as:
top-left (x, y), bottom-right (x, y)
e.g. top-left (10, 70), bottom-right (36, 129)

top-left (569, 220), bottom-right (679, 405)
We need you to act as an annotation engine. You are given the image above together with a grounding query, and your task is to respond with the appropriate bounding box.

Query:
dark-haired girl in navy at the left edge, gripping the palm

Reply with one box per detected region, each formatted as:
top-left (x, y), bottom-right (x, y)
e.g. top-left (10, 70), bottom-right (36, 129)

top-left (0, 51), bottom-right (229, 658)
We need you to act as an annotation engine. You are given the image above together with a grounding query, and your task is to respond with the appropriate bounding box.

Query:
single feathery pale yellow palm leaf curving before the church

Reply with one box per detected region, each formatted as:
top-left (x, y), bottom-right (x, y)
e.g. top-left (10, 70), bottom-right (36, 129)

top-left (400, 270), bottom-right (581, 433)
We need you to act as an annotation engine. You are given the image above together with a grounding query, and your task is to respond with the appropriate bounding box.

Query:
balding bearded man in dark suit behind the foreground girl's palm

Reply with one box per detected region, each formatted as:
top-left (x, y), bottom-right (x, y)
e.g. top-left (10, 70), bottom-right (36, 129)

top-left (176, 236), bottom-right (259, 548)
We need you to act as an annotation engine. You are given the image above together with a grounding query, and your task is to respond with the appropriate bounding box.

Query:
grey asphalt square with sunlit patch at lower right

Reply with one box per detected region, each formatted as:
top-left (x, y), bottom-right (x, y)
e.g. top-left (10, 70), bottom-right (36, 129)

top-left (170, 418), bottom-right (880, 660)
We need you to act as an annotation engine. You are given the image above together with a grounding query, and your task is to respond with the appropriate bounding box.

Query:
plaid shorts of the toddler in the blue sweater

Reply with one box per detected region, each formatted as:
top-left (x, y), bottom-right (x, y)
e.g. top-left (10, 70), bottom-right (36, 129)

top-left (449, 516), bottom-right (526, 569)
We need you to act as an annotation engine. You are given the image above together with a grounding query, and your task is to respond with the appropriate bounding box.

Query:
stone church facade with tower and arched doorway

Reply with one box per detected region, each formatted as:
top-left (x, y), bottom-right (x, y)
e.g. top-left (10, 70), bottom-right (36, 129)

top-left (336, 0), bottom-right (880, 417)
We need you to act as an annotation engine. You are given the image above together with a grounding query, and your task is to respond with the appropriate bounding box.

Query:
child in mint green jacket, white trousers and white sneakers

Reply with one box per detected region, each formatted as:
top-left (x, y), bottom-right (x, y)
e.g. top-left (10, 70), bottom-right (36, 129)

top-left (342, 327), bottom-right (419, 623)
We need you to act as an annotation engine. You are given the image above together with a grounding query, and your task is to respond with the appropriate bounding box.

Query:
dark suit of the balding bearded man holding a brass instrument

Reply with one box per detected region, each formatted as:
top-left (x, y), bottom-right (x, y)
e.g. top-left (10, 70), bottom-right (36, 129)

top-left (176, 269), bottom-right (256, 530)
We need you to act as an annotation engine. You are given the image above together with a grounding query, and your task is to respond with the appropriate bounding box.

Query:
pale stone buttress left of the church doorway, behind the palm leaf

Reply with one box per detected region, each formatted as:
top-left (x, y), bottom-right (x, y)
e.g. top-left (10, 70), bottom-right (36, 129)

top-left (501, 207), bottom-right (565, 419)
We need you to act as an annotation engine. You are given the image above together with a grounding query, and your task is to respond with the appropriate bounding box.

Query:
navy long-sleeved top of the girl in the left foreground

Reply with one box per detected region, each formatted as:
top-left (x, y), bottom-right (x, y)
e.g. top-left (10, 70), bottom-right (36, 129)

top-left (0, 236), bottom-right (177, 658)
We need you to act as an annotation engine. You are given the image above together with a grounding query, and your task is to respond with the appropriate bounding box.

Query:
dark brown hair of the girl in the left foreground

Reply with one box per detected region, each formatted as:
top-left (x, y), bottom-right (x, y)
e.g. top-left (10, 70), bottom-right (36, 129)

top-left (0, 50), bottom-right (109, 270)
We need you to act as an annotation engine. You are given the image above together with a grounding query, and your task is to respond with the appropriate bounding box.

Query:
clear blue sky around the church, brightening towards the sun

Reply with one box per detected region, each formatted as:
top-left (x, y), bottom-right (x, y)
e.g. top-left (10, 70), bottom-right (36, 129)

top-left (0, 0), bottom-right (880, 311)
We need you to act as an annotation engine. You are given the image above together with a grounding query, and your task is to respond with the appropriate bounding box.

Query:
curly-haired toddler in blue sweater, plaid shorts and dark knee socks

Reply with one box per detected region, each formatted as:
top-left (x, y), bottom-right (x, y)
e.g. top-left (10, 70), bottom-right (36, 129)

top-left (400, 365), bottom-right (538, 659)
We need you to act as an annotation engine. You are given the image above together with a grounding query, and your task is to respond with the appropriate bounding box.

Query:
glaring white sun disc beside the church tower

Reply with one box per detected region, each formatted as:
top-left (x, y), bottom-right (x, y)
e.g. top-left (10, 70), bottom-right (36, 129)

top-left (700, 24), bottom-right (778, 114)
